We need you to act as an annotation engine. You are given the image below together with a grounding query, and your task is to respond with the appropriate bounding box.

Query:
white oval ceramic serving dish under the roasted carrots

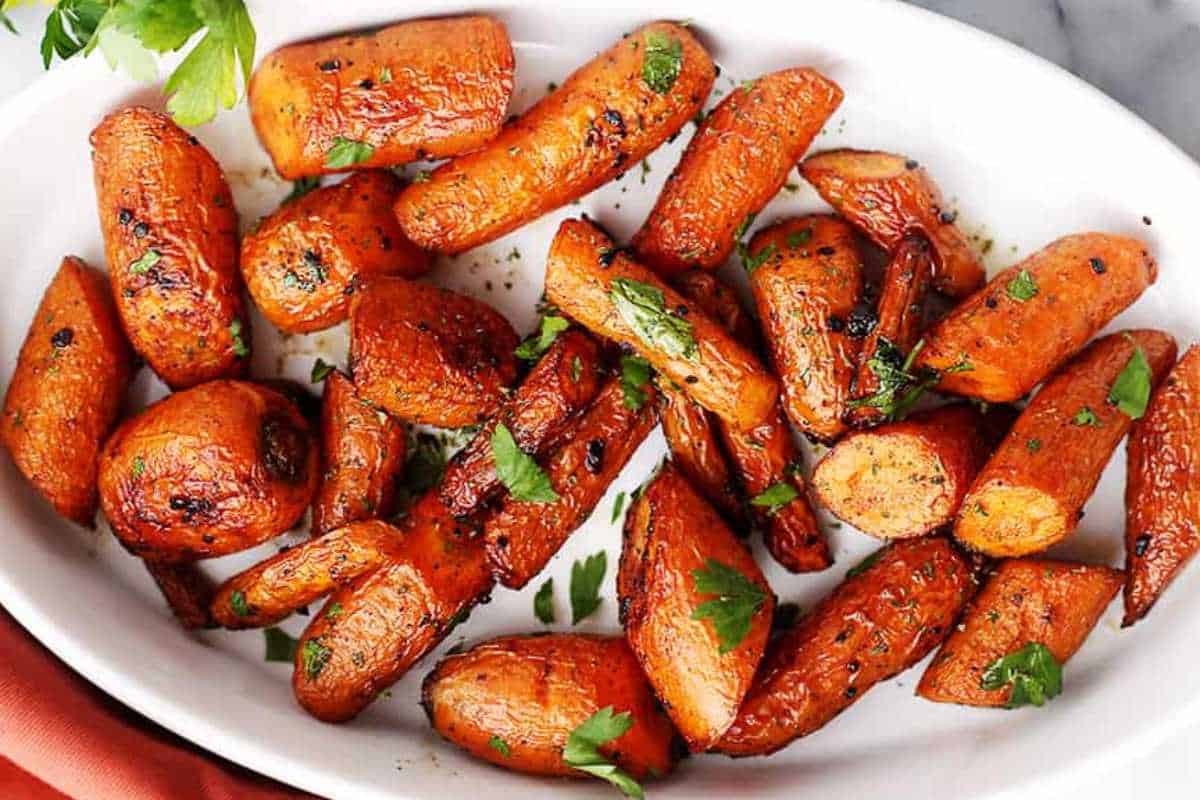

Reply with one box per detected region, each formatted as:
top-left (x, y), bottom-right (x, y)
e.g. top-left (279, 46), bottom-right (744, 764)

top-left (0, 0), bottom-right (1200, 799)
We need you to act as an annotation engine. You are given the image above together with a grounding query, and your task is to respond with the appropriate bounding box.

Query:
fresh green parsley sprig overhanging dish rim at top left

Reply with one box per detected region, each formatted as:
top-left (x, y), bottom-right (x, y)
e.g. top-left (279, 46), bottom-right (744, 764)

top-left (41, 0), bottom-right (257, 126)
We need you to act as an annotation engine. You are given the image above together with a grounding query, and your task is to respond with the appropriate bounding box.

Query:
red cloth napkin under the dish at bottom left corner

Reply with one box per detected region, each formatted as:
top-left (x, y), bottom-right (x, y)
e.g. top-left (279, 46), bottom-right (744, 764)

top-left (0, 609), bottom-right (312, 800)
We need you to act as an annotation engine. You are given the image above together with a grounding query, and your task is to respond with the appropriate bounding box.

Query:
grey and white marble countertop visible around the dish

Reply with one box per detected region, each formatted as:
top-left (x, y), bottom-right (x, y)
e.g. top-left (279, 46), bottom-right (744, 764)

top-left (0, 0), bottom-right (1200, 800)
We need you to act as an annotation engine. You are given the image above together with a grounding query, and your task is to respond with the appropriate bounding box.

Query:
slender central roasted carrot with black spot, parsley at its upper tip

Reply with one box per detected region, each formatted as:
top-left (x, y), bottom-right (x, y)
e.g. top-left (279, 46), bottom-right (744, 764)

top-left (484, 378), bottom-right (658, 589)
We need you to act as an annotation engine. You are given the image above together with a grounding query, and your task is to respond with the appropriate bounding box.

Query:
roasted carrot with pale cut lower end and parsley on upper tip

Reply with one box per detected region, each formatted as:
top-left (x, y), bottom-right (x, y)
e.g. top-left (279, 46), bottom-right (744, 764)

top-left (954, 330), bottom-right (1175, 557)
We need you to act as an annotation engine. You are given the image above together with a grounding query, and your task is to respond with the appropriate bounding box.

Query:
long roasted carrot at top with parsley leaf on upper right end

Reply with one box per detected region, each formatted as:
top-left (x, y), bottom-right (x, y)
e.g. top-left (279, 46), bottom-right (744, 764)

top-left (396, 22), bottom-right (715, 253)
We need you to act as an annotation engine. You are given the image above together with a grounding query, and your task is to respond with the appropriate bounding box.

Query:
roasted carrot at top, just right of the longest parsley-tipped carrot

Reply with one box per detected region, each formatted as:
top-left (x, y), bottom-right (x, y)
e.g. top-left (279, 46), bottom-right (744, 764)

top-left (632, 67), bottom-right (842, 277)
